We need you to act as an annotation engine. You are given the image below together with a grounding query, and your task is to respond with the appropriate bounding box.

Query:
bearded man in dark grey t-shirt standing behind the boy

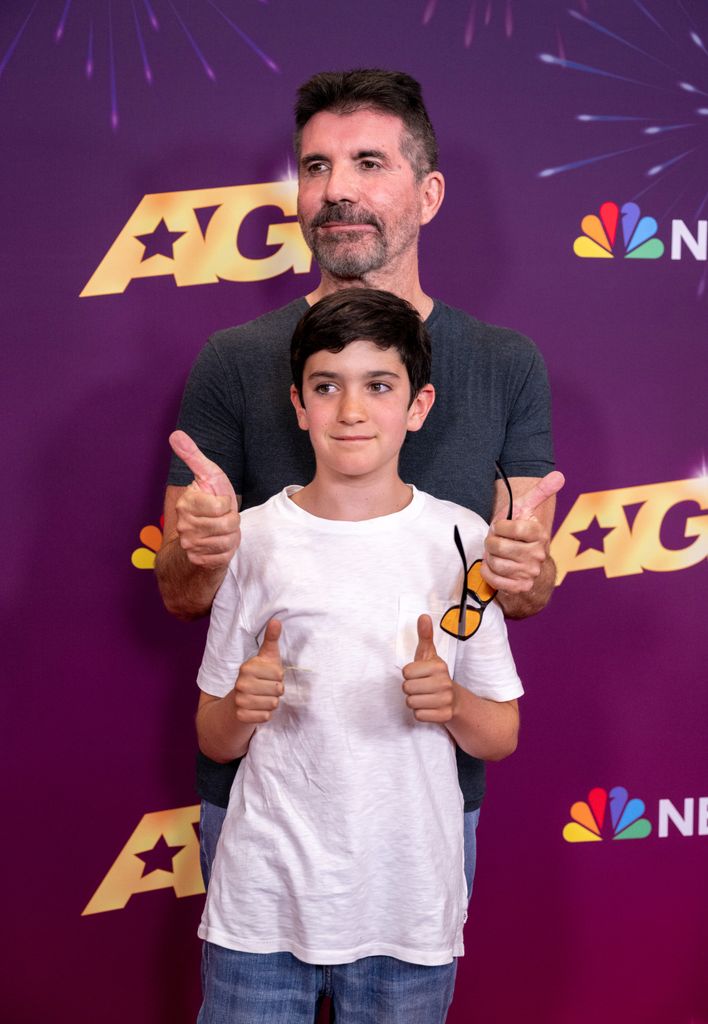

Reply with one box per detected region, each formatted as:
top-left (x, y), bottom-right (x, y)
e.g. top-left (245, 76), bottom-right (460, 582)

top-left (156, 71), bottom-right (563, 890)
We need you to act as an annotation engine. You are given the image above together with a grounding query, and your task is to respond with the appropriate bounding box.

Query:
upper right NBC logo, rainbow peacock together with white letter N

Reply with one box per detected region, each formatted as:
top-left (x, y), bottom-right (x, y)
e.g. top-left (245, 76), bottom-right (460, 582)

top-left (573, 203), bottom-right (708, 260)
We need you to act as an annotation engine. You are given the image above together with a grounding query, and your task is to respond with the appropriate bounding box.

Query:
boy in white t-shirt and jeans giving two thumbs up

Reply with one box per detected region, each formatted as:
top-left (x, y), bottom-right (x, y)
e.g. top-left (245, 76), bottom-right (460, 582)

top-left (192, 289), bottom-right (523, 1024)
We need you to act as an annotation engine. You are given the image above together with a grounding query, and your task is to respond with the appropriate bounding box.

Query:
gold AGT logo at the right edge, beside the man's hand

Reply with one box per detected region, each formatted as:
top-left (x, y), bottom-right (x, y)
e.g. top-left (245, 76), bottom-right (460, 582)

top-left (550, 476), bottom-right (708, 584)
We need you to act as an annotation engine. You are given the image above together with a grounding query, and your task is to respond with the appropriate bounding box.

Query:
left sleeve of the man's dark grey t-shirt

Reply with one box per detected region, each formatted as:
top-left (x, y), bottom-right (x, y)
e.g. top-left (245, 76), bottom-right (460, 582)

top-left (167, 338), bottom-right (244, 494)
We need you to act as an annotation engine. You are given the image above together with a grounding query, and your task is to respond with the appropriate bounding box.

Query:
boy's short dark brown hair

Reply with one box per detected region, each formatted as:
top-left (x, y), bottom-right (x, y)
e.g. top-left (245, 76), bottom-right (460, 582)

top-left (290, 288), bottom-right (431, 404)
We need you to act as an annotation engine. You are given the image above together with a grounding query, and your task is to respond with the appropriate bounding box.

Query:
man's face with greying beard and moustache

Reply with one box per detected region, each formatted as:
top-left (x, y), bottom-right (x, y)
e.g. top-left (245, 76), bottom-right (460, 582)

top-left (297, 110), bottom-right (423, 280)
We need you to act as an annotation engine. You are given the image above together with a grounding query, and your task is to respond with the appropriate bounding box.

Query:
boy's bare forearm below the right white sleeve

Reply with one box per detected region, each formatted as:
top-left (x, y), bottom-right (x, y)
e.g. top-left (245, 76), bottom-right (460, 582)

top-left (446, 683), bottom-right (518, 761)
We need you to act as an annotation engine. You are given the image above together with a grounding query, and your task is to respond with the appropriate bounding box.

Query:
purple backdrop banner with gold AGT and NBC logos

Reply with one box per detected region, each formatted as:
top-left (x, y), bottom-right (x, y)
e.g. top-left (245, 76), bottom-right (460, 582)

top-left (0, 0), bottom-right (708, 1024)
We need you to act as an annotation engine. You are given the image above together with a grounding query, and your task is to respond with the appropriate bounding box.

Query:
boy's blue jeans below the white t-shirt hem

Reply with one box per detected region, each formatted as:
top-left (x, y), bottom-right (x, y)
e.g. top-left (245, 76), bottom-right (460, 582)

top-left (197, 943), bottom-right (457, 1024)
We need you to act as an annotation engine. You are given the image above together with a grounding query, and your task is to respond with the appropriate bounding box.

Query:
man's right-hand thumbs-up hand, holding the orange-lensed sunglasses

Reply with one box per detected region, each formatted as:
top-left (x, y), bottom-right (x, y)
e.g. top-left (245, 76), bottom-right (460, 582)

top-left (482, 471), bottom-right (566, 617)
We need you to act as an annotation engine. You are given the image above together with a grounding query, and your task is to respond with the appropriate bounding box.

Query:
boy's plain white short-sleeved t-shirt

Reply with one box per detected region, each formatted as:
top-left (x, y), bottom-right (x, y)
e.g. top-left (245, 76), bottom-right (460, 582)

top-left (198, 487), bottom-right (523, 965)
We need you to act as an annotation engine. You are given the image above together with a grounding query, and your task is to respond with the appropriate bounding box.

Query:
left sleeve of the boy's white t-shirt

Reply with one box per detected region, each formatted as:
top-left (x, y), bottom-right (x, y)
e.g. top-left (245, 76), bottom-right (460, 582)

top-left (197, 555), bottom-right (258, 697)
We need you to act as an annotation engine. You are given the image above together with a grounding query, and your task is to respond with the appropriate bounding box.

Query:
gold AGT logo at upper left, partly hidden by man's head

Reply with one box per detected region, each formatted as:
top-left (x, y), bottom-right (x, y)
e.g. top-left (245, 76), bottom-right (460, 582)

top-left (81, 181), bottom-right (313, 298)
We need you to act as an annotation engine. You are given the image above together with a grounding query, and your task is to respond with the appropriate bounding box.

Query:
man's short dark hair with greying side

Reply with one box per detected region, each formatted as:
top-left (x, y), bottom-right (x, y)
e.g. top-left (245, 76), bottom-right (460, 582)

top-left (295, 68), bottom-right (438, 180)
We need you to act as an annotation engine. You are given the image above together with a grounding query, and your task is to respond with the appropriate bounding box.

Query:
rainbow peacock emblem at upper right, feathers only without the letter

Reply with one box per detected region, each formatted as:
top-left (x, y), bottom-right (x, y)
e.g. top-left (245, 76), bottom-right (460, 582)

top-left (573, 203), bottom-right (664, 259)
